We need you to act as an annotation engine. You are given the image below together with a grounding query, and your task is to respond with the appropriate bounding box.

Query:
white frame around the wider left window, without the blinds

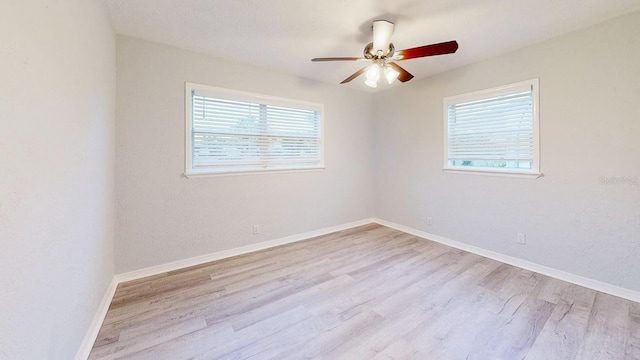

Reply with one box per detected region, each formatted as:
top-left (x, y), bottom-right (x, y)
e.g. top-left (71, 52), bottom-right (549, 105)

top-left (184, 82), bottom-right (325, 178)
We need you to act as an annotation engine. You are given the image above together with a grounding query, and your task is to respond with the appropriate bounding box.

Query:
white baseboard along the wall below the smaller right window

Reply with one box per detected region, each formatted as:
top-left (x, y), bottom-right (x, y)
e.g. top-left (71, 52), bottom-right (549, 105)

top-left (373, 218), bottom-right (640, 302)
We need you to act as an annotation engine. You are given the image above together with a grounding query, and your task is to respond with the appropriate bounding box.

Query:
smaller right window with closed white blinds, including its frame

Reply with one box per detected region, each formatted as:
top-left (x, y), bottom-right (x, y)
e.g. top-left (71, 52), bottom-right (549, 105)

top-left (444, 79), bottom-right (540, 177)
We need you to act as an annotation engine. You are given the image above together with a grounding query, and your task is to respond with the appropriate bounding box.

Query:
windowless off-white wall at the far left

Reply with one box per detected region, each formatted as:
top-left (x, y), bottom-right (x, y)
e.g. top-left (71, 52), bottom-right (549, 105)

top-left (0, 0), bottom-right (115, 360)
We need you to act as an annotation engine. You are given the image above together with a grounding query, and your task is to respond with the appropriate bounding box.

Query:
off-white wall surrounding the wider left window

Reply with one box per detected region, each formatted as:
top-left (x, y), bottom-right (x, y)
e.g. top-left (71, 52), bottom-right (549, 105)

top-left (116, 36), bottom-right (373, 273)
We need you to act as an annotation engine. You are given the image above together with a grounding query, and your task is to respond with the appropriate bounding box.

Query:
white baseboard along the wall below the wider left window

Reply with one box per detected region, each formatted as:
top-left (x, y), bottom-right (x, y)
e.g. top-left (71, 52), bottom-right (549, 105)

top-left (115, 218), bottom-right (374, 283)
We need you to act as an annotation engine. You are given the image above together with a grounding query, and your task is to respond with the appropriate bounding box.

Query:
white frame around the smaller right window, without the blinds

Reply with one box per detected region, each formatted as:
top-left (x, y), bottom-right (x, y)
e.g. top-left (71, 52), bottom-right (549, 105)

top-left (442, 78), bottom-right (543, 179)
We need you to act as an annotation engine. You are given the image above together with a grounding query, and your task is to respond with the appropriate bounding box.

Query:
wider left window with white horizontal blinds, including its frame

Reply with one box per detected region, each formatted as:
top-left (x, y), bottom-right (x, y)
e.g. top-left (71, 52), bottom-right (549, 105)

top-left (185, 83), bottom-right (324, 176)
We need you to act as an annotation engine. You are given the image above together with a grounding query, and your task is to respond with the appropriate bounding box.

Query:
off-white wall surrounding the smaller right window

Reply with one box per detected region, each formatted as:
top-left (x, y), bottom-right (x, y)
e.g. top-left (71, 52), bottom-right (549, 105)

top-left (375, 13), bottom-right (640, 290)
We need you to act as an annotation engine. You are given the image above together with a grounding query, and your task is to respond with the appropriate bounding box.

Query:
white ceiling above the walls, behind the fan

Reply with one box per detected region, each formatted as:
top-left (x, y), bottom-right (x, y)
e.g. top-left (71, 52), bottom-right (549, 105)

top-left (105, 0), bottom-right (640, 89)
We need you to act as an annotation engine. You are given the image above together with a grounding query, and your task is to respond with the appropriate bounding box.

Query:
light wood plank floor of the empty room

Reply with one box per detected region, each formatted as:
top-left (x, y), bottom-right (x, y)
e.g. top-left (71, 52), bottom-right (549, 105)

top-left (90, 225), bottom-right (640, 360)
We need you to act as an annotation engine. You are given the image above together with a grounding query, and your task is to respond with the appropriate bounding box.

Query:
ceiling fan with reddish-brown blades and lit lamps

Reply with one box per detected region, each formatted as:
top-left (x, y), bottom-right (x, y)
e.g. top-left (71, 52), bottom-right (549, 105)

top-left (311, 20), bottom-right (458, 88)
